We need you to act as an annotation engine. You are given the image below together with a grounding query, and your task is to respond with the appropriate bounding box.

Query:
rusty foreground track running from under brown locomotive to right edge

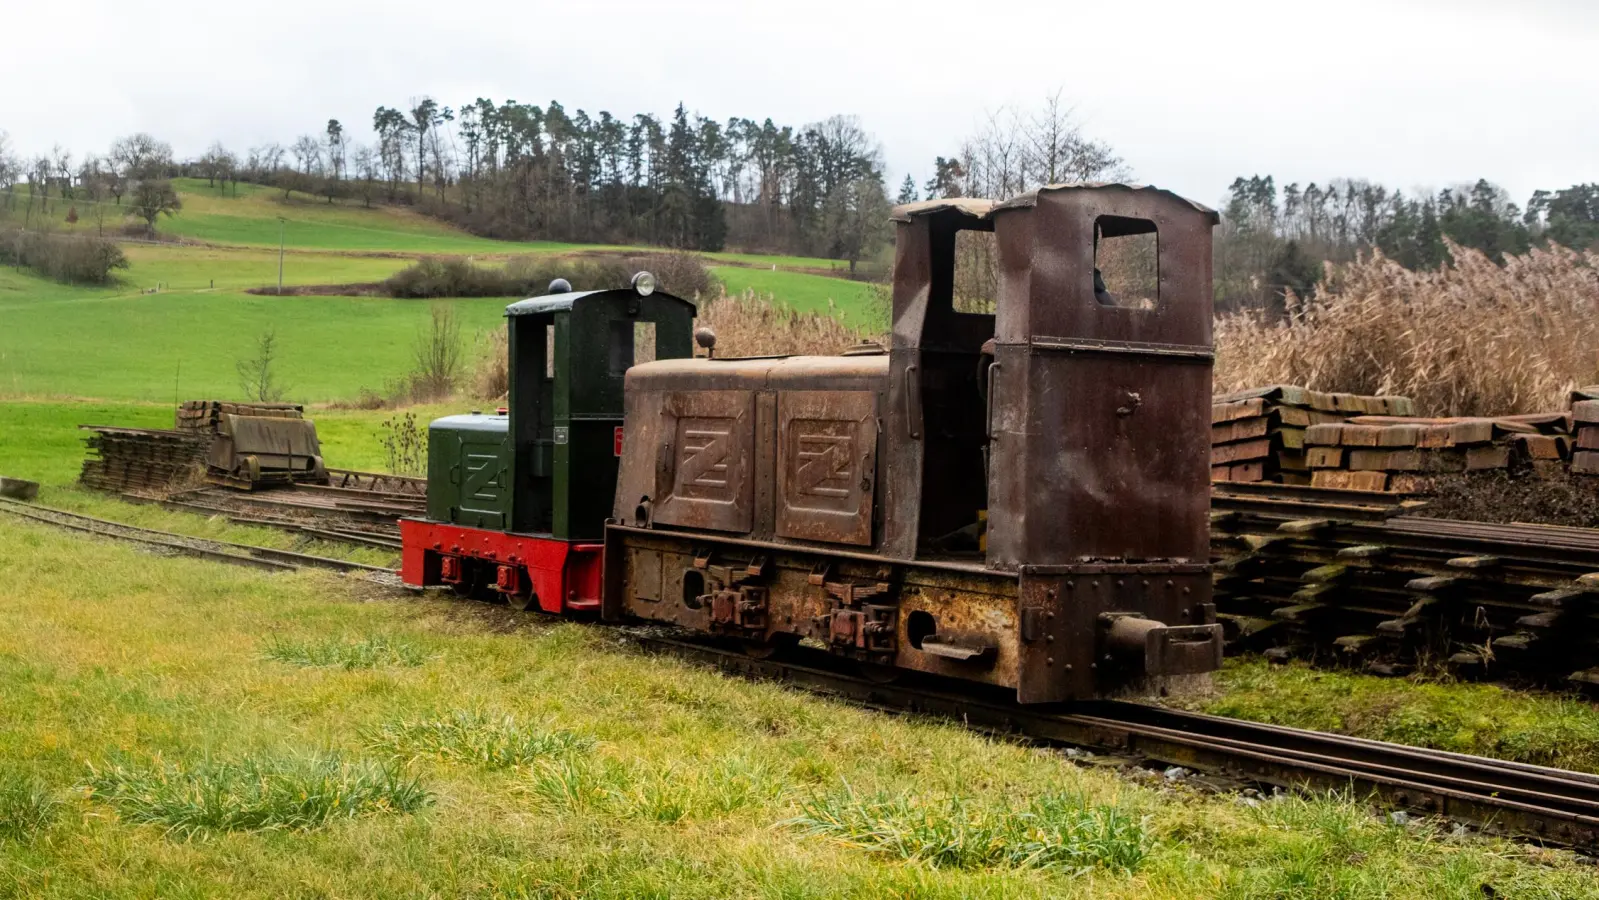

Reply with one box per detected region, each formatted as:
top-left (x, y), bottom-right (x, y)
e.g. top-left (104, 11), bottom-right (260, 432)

top-left (632, 633), bottom-right (1599, 852)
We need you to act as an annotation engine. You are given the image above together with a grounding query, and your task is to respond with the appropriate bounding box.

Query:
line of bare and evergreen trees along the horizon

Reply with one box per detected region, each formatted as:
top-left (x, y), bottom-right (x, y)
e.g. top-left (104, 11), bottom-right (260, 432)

top-left (0, 93), bottom-right (1599, 302)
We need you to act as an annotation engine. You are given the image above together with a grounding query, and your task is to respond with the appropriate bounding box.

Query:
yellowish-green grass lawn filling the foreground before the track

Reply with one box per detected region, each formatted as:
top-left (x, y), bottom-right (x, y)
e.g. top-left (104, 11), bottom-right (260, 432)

top-left (0, 516), bottom-right (1599, 900)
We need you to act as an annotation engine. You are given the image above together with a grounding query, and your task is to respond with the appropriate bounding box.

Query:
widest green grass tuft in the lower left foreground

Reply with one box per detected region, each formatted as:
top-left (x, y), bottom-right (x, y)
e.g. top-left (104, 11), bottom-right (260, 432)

top-left (86, 753), bottom-right (433, 838)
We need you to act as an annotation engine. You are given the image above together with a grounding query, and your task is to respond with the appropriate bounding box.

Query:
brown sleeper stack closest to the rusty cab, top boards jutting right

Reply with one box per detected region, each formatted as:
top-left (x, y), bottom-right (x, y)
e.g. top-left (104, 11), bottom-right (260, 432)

top-left (1210, 384), bottom-right (1415, 484)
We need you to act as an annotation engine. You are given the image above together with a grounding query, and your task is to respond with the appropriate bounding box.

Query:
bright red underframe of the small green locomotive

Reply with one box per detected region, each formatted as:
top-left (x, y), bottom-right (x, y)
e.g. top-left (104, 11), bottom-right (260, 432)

top-left (400, 520), bottom-right (601, 614)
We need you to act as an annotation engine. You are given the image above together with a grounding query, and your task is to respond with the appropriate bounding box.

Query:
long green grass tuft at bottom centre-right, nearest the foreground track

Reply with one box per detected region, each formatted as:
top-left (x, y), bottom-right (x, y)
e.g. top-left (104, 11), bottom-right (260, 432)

top-left (782, 785), bottom-right (1151, 873)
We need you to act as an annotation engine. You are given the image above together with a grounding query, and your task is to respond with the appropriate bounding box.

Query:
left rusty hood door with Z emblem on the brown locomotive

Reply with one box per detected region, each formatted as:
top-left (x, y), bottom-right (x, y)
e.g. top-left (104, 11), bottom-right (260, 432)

top-left (654, 390), bottom-right (755, 532)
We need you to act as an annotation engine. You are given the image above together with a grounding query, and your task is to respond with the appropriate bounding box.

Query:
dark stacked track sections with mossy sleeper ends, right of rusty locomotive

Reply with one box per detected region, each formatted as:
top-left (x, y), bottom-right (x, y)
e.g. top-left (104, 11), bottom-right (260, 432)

top-left (1212, 484), bottom-right (1599, 686)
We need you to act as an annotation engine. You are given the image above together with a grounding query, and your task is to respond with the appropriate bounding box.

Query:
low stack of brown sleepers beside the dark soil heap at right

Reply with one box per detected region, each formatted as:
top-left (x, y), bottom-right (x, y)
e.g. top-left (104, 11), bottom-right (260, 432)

top-left (1305, 415), bottom-right (1573, 491)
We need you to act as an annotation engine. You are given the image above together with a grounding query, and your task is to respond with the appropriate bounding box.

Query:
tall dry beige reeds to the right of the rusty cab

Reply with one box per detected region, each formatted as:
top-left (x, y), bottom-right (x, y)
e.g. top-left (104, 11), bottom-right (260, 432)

top-left (1215, 243), bottom-right (1599, 416)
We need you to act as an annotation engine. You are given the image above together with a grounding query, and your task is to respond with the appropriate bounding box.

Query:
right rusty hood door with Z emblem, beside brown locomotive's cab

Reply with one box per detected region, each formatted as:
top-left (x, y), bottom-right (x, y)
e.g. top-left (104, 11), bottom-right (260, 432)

top-left (777, 390), bottom-right (878, 545)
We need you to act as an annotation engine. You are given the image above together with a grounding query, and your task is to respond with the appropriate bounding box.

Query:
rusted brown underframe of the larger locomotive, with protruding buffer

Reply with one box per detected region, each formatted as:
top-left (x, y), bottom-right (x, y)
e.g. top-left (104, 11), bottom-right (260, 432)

top-left (604, 524), bottom-right (1222, 703)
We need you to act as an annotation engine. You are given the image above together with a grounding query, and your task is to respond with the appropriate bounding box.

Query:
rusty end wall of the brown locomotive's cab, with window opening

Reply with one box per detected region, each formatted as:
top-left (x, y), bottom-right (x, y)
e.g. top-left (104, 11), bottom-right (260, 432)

top-left (988, 187), bottom-right (1214, 569)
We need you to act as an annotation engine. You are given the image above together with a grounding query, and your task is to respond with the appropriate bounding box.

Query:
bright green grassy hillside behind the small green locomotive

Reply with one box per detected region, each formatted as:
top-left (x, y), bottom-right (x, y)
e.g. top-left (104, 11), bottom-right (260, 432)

top-left (0, 179), bottom-right (873, 403)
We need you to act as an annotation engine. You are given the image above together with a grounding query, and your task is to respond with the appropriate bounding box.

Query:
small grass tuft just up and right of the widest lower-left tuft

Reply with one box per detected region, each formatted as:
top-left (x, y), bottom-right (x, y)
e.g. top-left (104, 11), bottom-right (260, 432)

top-left (363, 710), bottom-right (595, 769)
